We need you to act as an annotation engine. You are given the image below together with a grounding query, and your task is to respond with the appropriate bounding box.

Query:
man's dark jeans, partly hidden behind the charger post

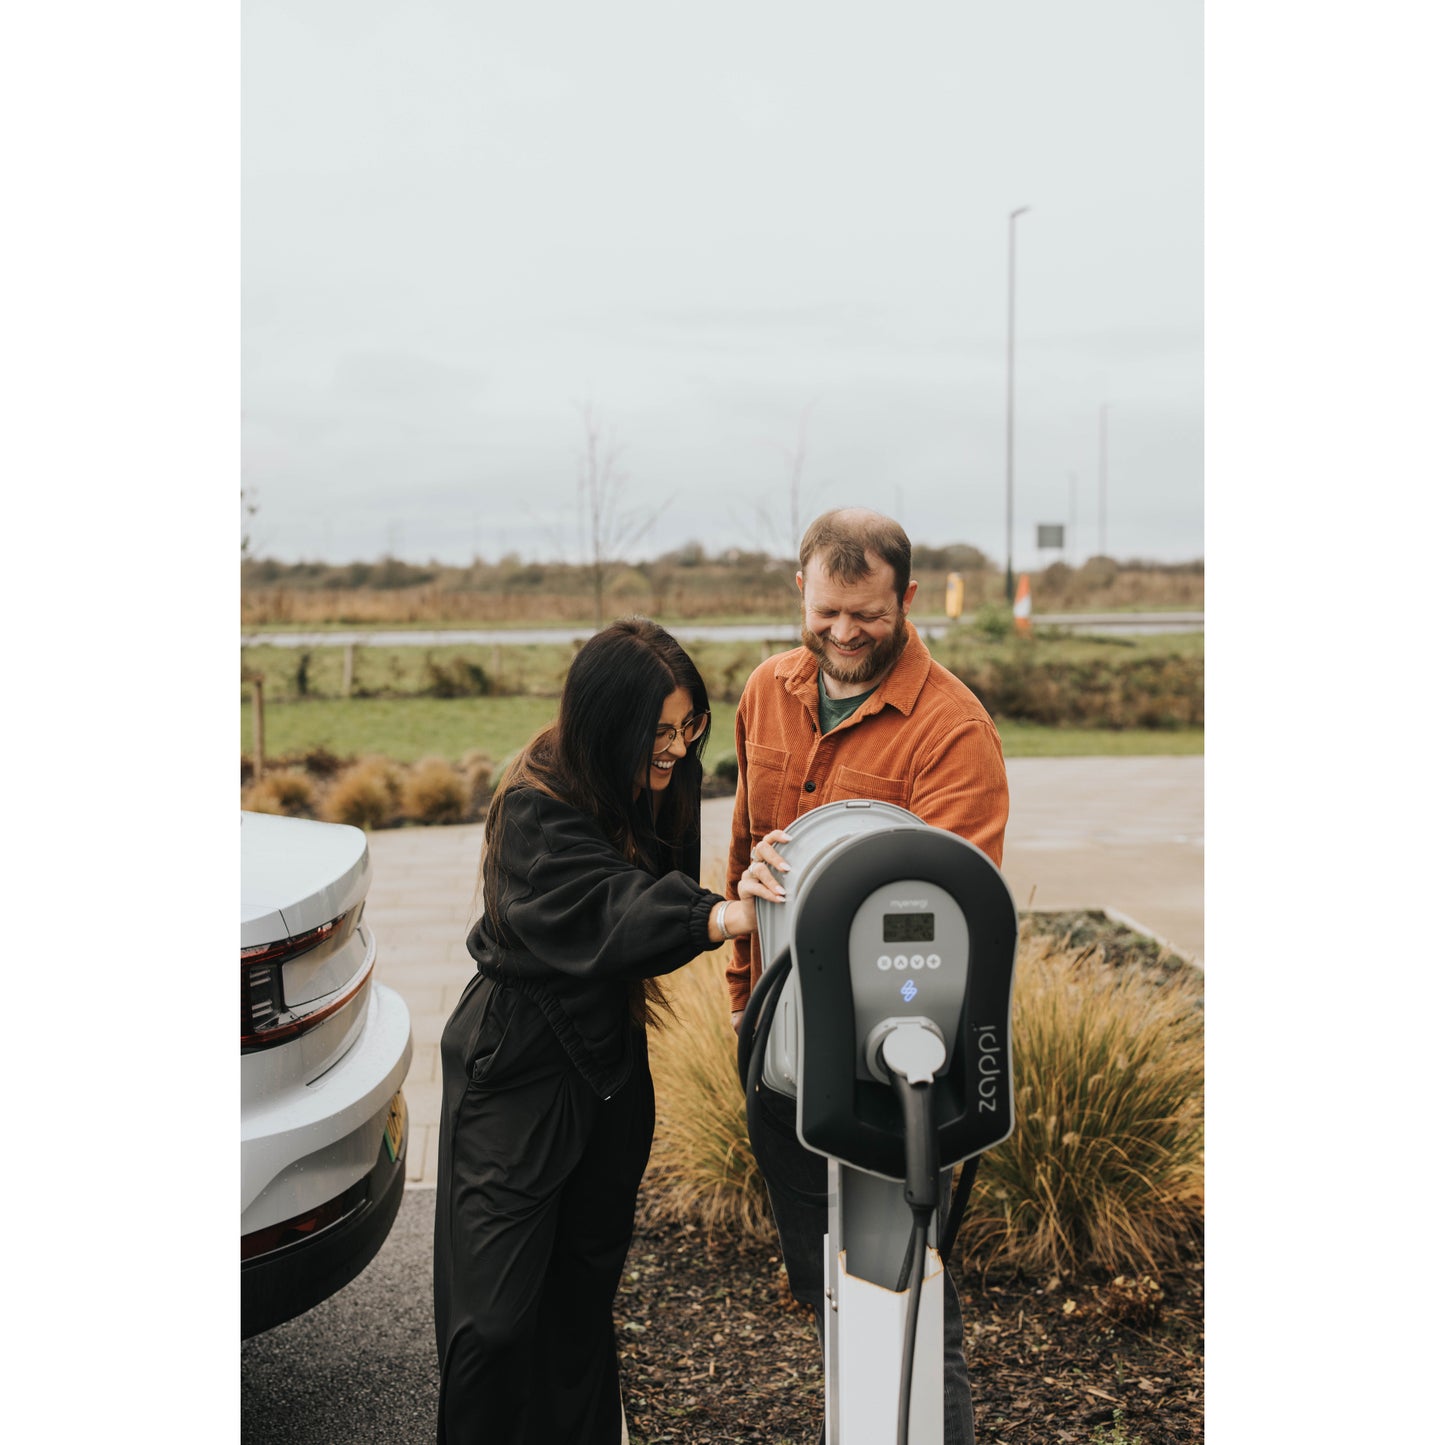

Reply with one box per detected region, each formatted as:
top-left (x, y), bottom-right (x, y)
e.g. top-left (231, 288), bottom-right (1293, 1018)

top-left (753, 1084), bottom-right (974, 1445)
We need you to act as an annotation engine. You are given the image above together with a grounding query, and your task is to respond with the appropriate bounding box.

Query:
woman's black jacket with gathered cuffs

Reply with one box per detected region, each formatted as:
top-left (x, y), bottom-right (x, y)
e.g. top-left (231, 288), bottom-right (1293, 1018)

top-left (467, 788), bottom-right (723, 1098)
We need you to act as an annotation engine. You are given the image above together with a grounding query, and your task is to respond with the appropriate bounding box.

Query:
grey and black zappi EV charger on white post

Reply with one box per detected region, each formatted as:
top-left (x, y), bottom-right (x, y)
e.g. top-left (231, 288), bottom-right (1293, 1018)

top-left (738, 799), bottom-right (1019, 1445)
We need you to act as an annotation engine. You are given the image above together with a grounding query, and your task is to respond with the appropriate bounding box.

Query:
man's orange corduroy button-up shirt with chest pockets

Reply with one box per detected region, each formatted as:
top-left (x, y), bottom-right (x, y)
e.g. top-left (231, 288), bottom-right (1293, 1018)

top-left (727, 623), bottom-right (1009, 1012)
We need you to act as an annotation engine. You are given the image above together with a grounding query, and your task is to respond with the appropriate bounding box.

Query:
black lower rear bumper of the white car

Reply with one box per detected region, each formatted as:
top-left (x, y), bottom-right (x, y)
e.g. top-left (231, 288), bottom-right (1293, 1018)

top-left (241, 1092), bottom-right (410, 1338)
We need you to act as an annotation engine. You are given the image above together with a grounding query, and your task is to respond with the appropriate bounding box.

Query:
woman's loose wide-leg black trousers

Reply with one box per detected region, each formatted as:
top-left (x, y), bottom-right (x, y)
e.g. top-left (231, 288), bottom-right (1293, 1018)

top-left (434, 975), bottom-right (655, 1445)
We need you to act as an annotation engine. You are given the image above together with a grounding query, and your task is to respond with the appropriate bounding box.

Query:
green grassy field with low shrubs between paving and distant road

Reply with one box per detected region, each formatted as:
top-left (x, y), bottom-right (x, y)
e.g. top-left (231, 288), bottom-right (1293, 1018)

top-left (240, 627), bottom-right (1204, 766)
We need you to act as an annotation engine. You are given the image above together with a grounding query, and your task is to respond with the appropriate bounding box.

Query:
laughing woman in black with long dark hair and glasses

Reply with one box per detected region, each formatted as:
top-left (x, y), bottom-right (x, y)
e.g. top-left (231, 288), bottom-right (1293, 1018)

top-left (435, 618), bottom-right (785, 1445)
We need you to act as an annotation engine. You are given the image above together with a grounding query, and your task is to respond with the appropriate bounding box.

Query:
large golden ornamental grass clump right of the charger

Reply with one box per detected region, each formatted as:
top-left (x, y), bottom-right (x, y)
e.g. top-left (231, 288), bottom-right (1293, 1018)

top-left (959, 936), bottom-right (1204, 1274)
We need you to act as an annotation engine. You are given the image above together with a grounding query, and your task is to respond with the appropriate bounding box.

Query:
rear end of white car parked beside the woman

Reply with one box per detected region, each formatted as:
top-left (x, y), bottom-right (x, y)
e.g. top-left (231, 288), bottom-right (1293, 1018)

top-left (241, 812), bottom-right (412, 1338)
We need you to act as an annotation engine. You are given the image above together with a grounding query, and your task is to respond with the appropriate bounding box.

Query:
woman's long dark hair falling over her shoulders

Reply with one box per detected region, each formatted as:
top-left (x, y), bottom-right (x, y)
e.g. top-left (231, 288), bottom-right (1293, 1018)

top-left (481, 617), bottom-right (711, 1023)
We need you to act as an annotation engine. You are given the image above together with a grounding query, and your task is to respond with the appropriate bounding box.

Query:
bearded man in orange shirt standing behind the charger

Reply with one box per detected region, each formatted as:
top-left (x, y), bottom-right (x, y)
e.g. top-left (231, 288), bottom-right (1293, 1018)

top-left (727, 507), bottom-right (1009, 1445)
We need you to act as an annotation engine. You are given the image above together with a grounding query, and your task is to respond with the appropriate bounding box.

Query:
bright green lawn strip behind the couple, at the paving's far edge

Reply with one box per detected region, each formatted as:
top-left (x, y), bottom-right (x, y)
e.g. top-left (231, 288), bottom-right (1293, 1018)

top-left (240, 698), bottom-right (1204, 764)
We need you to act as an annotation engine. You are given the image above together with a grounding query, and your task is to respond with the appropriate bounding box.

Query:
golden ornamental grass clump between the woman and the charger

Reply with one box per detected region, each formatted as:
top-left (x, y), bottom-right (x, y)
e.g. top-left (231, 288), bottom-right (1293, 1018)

top-left (642, 948), bottom-right (773, 1240)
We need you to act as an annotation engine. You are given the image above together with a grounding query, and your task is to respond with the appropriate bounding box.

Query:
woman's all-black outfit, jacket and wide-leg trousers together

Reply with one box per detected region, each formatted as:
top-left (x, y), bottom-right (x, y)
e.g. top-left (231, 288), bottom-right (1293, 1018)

top-left (435, 789), bottom-right (721, 1445)
